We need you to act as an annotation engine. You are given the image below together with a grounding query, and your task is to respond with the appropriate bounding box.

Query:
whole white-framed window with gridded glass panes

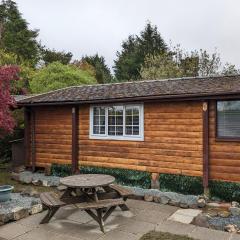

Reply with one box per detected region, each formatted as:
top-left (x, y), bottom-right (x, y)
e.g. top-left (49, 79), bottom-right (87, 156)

top-left (89, 104), bottom-right (144, 141)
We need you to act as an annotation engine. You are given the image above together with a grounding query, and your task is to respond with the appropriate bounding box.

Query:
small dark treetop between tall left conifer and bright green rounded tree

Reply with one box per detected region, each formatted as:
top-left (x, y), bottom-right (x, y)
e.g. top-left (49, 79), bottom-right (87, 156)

top-left (41, 48), bottom-right (73, 65)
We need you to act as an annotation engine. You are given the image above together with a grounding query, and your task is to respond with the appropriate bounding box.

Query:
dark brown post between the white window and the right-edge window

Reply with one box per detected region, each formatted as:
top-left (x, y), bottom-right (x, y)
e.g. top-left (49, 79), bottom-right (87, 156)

top-left (202, 101), bottom-right (209, 195)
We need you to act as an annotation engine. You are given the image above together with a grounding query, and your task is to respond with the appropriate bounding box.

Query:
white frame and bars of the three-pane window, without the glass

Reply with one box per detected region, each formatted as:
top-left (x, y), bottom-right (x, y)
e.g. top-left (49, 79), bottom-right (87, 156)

top-left (89, 103), bottom-right (144, 141)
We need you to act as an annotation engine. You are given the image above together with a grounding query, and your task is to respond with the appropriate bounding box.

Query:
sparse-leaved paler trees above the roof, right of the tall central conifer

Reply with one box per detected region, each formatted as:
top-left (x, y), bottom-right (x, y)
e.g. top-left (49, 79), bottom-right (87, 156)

top-left (141, 46), bottom-right (240, 79)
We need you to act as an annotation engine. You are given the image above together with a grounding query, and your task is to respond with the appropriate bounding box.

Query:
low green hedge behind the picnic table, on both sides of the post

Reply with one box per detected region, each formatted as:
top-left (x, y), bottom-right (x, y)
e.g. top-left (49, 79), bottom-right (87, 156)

top-left (51, 164), bottom-right (151, 188)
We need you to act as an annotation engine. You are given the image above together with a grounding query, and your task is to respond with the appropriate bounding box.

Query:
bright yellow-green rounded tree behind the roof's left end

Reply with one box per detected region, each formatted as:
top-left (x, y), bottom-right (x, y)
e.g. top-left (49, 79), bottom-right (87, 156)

top-left (30, 62), bottom-right (97, 93)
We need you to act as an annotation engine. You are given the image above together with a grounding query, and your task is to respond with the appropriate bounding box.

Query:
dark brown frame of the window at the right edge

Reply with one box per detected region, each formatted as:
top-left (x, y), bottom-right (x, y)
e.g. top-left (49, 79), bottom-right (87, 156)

top-left (214, 99), bottom-right (240, 142)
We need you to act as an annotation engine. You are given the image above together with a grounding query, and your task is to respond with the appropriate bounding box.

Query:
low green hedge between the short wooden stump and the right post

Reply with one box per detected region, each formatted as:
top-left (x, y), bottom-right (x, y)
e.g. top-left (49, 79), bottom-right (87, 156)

top-left (159, 174), bottom-right (203, 195)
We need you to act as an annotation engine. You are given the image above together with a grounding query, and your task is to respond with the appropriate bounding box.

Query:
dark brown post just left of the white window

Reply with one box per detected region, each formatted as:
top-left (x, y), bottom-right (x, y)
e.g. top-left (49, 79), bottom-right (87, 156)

top-left (72, 106), bottom-right (79, 174)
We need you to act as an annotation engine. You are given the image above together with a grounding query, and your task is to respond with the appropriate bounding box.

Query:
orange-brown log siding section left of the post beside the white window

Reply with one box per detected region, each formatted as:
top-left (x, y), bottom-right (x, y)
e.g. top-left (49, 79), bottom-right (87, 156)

top-left (35, 106), bottom-right (72, 166)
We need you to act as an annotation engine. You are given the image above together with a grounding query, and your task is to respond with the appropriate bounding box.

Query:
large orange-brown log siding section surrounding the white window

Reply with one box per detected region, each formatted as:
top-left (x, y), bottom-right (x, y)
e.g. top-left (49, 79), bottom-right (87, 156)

top-left (79, 102), bottom-right (202, 176)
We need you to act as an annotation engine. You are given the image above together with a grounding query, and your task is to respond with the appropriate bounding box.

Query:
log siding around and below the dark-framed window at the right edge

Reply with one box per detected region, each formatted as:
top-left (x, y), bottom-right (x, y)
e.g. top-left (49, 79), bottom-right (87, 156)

top-left (209, 101), bottom-right (240, 181)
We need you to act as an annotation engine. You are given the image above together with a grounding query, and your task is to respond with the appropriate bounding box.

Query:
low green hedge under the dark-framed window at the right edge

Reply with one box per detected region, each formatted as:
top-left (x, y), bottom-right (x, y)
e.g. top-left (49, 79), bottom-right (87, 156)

top-left (209, 181), bottom-right (240, 202)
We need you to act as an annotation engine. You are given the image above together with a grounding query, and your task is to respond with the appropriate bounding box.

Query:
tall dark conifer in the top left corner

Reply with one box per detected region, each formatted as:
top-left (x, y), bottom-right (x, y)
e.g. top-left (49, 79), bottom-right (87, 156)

top-left (0, 0), bottom-right (39, 64)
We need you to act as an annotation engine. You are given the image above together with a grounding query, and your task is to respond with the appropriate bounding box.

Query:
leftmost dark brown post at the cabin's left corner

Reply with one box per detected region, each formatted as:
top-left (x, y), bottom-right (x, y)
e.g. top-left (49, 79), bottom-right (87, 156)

top-left (24, 107), bottom-right (31, 165)
